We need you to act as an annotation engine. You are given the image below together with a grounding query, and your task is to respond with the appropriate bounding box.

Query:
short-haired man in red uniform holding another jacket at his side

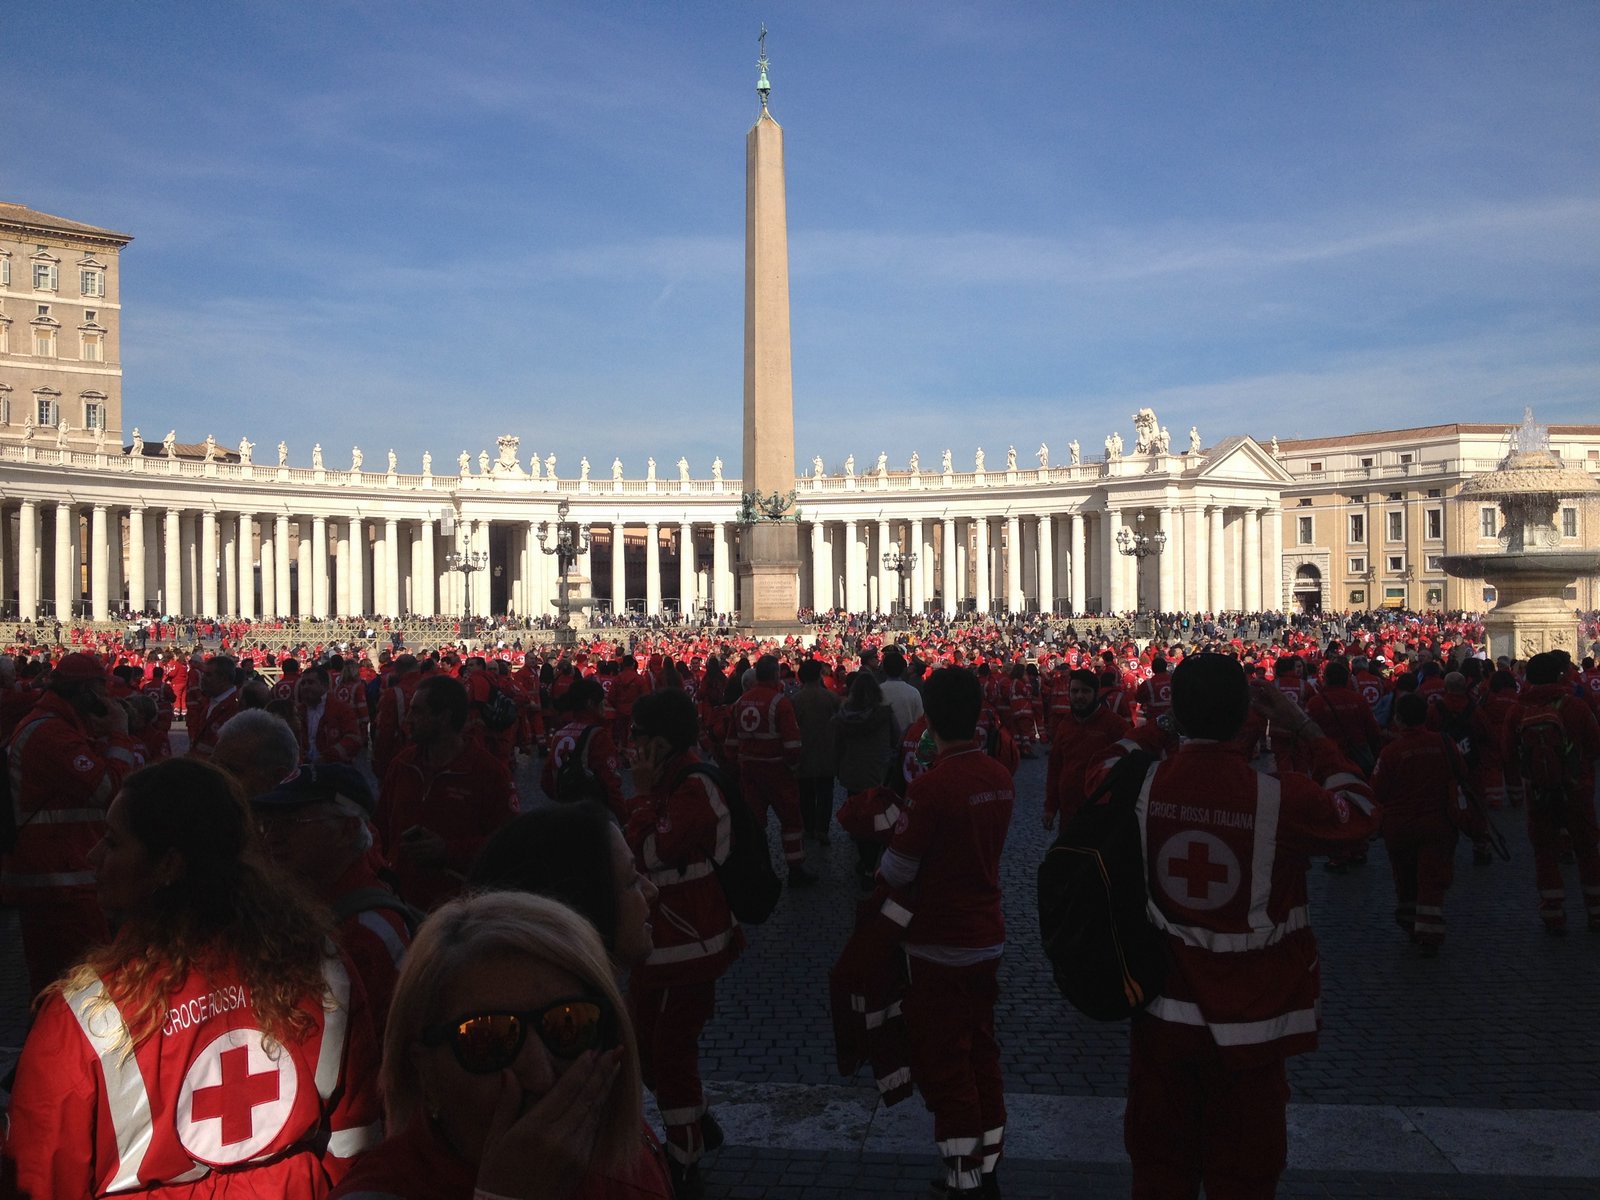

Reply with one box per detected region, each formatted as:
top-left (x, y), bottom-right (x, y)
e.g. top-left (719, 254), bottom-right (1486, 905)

top-left (878, 667), bottom-right (1014, 1197)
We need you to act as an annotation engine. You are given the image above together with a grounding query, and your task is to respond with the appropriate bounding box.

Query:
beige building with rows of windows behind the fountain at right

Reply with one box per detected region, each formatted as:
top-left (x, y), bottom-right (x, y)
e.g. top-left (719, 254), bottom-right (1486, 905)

top-left (1277, 414), bottom-right (1600, 611)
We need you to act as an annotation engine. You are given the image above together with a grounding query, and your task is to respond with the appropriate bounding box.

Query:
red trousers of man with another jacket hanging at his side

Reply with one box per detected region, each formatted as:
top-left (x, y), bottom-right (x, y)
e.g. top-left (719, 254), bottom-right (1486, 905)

top-left (901, 955), bottom-right (1005, 1192)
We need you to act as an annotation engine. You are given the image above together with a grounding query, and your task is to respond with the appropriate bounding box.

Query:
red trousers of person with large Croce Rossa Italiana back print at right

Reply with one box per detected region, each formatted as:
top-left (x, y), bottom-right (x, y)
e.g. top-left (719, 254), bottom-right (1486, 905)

top-left (1123, 1016), bottom-right (1290, 1200)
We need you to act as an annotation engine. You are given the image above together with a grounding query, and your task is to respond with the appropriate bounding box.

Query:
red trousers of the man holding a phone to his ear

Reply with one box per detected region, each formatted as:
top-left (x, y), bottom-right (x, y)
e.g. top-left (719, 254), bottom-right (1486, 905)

top-left (627, 979), bottom-right (717, 1166)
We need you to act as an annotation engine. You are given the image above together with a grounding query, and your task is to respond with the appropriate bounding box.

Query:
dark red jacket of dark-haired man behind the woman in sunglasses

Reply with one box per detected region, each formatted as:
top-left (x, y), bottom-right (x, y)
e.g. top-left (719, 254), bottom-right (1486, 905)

top-left (378, 742), bottom-right (518, 909)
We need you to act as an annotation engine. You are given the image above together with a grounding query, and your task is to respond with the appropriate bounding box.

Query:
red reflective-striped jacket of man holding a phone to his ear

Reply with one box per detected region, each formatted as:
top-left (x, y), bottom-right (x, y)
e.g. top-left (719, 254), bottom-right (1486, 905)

top-left (626, 750), bottom-right (744, 987)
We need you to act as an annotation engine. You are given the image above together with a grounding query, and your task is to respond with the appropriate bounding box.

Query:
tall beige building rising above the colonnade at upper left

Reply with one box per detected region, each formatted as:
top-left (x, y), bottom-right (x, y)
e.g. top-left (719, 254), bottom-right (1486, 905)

top-left (0, 202), bottom-right (133, 446)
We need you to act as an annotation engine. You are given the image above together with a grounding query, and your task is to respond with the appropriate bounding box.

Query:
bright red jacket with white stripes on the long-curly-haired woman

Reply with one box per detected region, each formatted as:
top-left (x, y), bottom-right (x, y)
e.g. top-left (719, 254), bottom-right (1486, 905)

top-left (6, 958), bottom-right (381, 1200)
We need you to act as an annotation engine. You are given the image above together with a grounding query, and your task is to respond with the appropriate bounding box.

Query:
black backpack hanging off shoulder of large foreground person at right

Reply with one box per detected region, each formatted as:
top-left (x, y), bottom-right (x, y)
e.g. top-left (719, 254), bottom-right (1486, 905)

top-left (1038, 750), bottom-right (1168, 1021)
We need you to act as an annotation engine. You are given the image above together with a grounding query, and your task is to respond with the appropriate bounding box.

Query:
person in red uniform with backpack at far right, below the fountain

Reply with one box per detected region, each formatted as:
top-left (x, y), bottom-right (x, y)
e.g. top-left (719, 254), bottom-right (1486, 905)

top-left (1504, 650), bottom-right (1600, 934)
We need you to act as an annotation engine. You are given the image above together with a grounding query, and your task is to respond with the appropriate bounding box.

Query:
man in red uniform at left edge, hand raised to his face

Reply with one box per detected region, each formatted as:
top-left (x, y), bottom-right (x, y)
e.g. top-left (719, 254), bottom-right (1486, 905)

top-left (0, 653), bottom-right (138, 995)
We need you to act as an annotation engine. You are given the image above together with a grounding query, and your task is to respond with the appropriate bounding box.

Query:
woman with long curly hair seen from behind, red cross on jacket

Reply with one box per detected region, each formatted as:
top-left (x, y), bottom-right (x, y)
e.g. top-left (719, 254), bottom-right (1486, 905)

top-left (6, 758), bottom-right (378, 1200)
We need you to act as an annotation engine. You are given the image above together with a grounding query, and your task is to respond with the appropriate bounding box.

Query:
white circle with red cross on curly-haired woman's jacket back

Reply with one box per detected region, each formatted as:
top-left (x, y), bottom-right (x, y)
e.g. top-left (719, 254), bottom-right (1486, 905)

top-left (176, 1029), bottom-right (299, 1166)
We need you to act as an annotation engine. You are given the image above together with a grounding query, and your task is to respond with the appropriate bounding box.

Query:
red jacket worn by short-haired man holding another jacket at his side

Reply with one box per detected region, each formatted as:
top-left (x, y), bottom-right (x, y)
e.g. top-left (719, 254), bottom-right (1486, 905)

top-left (888, 741), bottom-right (1016, 949)
